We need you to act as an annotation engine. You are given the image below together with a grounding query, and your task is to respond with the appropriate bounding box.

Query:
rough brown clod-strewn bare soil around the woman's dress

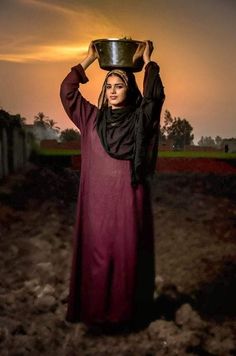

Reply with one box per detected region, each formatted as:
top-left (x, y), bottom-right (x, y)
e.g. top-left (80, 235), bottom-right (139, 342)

top-left (0, 165), bottom-right (236, 356)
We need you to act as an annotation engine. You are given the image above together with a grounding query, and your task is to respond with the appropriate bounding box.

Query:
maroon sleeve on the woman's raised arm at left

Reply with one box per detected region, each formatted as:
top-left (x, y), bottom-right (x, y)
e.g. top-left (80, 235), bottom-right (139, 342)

top-left (60, 64), bottom-right (97, 134)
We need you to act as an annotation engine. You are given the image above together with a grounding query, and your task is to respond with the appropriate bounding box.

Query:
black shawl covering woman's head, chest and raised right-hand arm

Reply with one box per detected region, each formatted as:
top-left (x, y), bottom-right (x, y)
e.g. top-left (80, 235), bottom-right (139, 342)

top-left (96, 62), bottom-right (165, 186)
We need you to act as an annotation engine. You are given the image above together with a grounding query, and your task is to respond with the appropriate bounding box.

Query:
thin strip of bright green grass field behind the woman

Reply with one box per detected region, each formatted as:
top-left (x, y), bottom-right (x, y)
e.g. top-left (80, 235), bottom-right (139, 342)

top-left (37, 148), bottom-right (236, 159)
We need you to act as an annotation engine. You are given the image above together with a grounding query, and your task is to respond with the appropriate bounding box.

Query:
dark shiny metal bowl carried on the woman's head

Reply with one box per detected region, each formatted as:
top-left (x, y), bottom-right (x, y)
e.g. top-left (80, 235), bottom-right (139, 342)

top-left (93, 38), bottom-right (145, 72)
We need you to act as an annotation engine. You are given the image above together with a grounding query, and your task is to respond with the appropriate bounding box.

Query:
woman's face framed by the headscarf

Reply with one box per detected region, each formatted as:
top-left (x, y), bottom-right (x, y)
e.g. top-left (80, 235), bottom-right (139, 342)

top-left (106, 75), bottom-right (127, 109)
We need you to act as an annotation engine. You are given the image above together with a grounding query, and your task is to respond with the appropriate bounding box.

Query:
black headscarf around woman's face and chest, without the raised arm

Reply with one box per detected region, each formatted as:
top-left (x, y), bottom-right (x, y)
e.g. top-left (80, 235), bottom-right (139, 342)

top-left (96, 65), bottom-right (163, 186)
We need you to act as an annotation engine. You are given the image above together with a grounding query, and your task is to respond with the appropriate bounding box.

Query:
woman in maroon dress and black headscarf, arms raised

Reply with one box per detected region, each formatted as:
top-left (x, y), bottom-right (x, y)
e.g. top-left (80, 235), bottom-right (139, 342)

top-left (60, 41), bottom-right (164, 326)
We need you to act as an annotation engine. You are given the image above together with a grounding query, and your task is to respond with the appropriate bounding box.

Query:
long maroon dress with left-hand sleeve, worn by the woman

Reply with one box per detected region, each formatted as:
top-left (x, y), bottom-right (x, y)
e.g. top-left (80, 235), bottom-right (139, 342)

top-left (61, 61), bottom-right (165, 325)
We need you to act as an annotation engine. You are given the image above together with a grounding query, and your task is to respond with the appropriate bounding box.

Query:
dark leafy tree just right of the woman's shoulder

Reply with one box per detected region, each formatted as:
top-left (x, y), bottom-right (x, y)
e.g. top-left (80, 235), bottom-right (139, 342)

top-left (162, 110), bottom-right (194, 149)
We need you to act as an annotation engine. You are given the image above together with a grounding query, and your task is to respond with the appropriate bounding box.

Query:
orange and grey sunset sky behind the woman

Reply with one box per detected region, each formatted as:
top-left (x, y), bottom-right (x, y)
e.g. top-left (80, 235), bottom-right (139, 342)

top-left (0, 0), bottom-right (236, 143)
